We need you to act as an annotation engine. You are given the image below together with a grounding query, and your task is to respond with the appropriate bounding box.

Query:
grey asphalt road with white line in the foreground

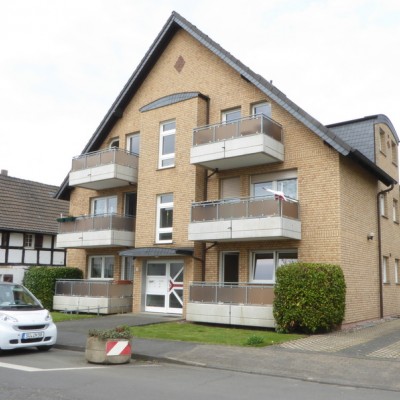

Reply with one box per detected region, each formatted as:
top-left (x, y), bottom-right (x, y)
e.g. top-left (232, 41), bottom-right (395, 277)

top-left (0, 349), bottom-right (399, 400)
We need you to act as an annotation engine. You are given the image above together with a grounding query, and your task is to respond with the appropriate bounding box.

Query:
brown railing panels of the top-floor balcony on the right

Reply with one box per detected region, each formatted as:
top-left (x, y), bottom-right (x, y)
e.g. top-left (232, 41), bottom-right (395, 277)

top-left (193, 115), bottom-right (283, 146)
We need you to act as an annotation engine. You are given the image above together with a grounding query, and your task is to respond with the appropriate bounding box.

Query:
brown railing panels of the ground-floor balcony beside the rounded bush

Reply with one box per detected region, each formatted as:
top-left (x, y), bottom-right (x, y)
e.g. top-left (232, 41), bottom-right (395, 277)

top-left (189, 282), bottom-right (274, 305)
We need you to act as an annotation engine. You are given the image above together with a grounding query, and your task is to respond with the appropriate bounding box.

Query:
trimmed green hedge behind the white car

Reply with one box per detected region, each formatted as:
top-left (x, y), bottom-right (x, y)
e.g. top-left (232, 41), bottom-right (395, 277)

top-left (23, 267), bottom-right (83, 310)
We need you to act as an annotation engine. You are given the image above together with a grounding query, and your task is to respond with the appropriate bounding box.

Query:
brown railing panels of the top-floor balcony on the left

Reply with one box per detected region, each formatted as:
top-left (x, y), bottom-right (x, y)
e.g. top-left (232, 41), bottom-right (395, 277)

top-left (71, 147), bottom-right (139, 172)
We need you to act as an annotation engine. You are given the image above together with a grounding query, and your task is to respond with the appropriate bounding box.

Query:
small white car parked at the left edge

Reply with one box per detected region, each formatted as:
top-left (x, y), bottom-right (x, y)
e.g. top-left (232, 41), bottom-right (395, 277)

top-left (0, 282), bottom-right (57, 351)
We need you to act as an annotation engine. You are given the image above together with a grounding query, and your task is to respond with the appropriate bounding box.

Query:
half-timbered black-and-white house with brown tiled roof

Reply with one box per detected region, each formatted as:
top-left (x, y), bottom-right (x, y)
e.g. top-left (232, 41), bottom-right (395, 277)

top-left (0, 169), bottom-right (69, 283)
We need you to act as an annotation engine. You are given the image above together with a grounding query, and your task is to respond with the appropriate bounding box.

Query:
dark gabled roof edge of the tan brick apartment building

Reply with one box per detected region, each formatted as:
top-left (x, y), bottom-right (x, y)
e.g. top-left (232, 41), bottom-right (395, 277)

top-left (57, 12), bottom-right (395, 198)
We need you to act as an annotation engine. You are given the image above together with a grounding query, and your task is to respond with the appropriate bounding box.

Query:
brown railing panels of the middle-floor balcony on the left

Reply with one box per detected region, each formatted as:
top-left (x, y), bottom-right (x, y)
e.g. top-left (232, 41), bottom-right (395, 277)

top-left (58, 214), bottom-right (136, 234)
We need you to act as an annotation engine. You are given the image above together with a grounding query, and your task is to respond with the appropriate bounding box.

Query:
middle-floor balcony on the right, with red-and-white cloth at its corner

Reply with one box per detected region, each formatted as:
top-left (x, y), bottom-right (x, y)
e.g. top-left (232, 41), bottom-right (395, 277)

top-left (188, 196), bottom-right (301, 242)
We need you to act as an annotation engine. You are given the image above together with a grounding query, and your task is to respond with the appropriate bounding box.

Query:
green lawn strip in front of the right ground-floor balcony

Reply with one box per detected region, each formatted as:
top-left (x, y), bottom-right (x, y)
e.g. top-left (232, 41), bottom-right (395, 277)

top-left (131, 322), bottom-right (304, 347)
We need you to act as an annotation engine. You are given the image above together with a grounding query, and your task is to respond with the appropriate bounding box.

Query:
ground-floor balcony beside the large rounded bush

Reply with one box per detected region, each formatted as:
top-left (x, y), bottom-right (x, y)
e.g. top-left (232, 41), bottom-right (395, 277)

top-left (186, 282), bottom-right (275, 328)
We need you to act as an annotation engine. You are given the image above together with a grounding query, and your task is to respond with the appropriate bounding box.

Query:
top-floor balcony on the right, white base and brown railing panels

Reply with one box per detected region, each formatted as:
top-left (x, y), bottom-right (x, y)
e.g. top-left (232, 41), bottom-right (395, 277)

top-left (190, 115), bottom-right (284, 170)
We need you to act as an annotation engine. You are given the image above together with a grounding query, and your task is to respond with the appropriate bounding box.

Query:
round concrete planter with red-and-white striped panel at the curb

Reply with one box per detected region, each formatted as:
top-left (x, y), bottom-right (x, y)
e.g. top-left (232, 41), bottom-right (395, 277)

top-left (85, 326), bottom-right (132, 364)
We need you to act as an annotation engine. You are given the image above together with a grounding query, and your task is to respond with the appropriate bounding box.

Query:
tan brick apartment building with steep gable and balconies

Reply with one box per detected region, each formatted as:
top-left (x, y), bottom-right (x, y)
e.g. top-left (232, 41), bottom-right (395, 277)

top-left (57, 12), bottom-right (400, 327)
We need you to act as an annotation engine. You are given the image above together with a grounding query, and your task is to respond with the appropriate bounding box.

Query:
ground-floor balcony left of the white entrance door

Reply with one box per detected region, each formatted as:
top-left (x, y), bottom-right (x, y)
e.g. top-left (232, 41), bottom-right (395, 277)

top-left (53, 279), bottom-right (133, 314)
